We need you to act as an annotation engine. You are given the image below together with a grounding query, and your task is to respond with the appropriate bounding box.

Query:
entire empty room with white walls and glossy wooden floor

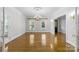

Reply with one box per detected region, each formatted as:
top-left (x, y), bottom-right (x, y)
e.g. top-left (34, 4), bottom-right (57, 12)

top-left (0, 7), bottom-right (79, 52)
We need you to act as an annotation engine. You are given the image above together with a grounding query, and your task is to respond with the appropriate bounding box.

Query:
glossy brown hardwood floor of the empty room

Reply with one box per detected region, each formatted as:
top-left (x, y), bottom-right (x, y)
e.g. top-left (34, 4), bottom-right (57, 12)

top-left (6, 32), bottom-right (74, 52)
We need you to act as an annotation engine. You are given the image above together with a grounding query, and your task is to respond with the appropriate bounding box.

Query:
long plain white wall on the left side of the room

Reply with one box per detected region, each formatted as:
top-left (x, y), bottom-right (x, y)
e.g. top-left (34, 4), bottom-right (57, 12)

top-left (5, 7), bottom-right (25, 43)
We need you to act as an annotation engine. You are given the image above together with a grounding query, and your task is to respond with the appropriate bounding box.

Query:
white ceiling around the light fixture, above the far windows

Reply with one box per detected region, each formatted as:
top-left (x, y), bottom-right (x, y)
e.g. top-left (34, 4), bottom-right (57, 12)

top-left (17, 7), bottom-right (60, 18)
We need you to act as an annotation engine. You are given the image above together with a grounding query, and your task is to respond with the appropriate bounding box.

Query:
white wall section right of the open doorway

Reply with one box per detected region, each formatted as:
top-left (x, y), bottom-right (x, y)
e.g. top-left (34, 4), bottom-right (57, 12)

top-left (66, 10), bottom-right (76, 46)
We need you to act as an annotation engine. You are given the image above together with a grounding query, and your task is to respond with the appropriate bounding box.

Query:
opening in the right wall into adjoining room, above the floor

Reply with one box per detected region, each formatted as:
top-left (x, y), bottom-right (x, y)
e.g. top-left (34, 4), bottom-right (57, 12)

top-left (54, 15), bottom-right (66, 34)
